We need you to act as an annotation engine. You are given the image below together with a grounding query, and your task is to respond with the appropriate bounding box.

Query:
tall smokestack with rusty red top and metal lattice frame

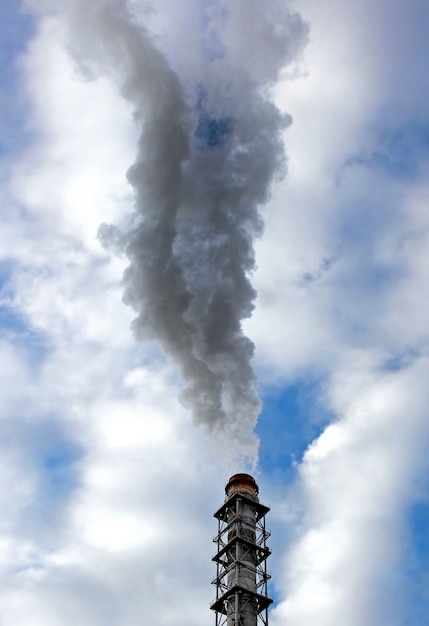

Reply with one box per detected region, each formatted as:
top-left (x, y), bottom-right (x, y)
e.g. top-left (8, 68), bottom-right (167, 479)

top-left (210, 474), bottom-right (272, 626)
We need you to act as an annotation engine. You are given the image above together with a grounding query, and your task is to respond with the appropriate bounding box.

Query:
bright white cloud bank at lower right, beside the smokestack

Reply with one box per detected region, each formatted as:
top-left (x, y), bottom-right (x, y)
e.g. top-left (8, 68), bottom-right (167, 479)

top-left (274, 358), bottom-right (429, 626)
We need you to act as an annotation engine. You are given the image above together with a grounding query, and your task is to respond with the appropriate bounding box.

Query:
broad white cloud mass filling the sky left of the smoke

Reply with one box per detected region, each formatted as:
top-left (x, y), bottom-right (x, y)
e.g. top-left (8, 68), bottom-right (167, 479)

top-left (0, 12), bottom-right (224, 626)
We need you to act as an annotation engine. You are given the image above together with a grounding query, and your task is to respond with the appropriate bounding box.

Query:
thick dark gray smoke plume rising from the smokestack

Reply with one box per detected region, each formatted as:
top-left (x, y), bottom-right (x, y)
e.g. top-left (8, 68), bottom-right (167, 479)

top-left (32, 0), bottom-right (307, 458)
